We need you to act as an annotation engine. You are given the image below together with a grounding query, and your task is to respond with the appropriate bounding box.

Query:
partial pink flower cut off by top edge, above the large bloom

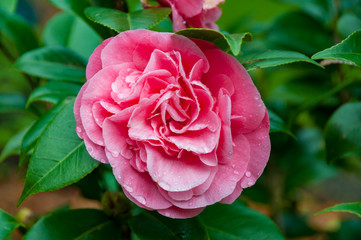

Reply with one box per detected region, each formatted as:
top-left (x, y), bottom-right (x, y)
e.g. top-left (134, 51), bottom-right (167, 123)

top-left (142, 0), bottom-right (224, 31)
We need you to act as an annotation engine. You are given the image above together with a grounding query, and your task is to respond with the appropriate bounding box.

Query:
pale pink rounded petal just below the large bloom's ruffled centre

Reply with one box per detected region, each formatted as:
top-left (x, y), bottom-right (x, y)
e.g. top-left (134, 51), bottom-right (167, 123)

top-left (146, 145), bottom-right (211, 192)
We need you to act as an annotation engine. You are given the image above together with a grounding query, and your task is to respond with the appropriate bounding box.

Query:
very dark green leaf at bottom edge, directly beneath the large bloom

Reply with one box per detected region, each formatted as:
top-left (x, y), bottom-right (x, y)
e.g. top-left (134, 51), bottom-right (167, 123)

top-left (129, 211), bottom-right (209, 240)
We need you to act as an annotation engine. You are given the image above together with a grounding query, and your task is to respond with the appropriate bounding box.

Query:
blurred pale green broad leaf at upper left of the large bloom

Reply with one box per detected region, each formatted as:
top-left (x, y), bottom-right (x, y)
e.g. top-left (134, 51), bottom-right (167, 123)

top-left (42, 12), bottom-right (101, 59)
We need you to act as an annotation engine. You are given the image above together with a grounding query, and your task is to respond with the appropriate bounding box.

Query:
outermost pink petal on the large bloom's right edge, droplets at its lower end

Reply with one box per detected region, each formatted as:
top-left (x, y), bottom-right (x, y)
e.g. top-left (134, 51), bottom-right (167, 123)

top-left (241, 112), bottom-right (271, 188)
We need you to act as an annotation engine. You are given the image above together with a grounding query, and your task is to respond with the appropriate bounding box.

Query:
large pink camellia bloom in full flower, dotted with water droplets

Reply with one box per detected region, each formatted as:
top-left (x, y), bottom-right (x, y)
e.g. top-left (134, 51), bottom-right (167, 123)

top-left (74, 30), bottom-right (270, 218)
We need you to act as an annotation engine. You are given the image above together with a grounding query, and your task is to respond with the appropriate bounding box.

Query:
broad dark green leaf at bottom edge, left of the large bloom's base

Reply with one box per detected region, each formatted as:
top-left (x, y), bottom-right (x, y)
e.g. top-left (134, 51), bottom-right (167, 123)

top-left (24, 209), bottom-right (122, 240)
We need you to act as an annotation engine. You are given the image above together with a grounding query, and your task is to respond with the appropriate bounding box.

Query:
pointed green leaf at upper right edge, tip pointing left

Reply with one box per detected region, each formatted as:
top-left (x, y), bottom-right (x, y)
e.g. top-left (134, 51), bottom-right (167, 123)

top-left (312, 30), bottom-right (361, 67)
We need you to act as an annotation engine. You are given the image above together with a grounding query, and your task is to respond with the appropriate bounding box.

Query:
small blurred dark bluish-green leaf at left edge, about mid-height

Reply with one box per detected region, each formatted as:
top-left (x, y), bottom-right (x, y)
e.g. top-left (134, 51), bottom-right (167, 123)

top-left (0, 93), bottom-right (26, 113)
